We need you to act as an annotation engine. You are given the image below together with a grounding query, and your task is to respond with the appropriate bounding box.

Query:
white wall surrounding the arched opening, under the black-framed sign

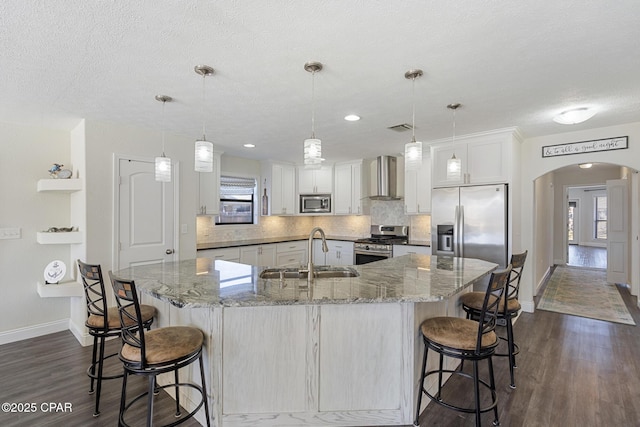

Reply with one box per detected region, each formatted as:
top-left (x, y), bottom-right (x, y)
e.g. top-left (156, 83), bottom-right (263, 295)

top-left (520, 122), bottom-right (640, 311)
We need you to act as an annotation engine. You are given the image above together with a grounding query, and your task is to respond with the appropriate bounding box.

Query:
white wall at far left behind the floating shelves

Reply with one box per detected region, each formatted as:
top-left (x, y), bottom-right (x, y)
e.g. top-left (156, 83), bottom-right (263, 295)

top-left (0, 123), bottom-right (74, 344)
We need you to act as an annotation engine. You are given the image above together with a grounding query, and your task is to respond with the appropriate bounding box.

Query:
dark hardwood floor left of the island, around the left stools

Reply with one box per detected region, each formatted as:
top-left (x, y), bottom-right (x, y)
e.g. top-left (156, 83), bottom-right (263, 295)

top-left (0, 331), bottom-right (200, 427)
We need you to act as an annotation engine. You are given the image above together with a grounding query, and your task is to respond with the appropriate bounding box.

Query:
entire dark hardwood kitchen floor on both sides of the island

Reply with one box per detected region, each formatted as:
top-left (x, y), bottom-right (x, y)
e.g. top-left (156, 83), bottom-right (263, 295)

top-left (0, 274), bottom-right (640, 427)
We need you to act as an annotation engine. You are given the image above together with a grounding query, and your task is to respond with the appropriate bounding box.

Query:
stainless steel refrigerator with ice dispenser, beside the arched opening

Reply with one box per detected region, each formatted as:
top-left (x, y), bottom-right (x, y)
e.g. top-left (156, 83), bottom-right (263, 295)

top-left (431, 184), bottom-right (509, 267)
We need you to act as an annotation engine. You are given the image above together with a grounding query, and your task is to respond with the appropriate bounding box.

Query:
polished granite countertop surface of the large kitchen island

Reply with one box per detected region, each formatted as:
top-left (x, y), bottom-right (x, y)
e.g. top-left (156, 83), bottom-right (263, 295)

top-left (115, 254), bottom-right (498, 307)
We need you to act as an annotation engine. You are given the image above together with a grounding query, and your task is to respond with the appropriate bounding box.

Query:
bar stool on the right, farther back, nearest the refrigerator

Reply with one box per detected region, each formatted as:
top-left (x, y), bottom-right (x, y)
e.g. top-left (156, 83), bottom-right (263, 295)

top-left (460, 251), bottom-right (528, 389)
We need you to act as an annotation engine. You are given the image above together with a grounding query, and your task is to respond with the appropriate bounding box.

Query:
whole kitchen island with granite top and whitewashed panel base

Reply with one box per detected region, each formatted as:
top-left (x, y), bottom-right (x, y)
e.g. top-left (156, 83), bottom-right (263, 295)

top-left (115, 254), bottom-right (497, 427)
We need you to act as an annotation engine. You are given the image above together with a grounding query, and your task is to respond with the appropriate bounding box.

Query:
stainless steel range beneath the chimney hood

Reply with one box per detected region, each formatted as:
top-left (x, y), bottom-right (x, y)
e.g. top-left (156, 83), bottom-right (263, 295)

top-left (353, 225), bottom-right (409, 265)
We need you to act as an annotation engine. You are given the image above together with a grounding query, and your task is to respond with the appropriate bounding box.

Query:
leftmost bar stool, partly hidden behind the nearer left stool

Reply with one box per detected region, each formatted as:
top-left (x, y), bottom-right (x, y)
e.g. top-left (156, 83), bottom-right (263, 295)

top-left (78, 260), bottom-right (156, 417)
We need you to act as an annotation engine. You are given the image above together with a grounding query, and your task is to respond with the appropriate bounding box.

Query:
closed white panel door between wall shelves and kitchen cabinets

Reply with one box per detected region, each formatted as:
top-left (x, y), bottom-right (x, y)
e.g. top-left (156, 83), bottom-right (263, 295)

top-left (116, 159), bottom-right (177, 269)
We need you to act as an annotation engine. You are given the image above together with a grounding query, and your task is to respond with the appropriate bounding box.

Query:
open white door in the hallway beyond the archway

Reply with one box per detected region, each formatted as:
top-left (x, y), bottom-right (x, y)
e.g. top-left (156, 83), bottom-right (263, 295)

top-left (607, 179), bottom-right (630, 283)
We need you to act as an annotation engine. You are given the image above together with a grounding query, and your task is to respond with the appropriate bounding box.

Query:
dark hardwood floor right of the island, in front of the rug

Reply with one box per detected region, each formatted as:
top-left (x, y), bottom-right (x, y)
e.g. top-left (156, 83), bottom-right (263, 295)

top-left (420, 274), bottom-right (640, 427)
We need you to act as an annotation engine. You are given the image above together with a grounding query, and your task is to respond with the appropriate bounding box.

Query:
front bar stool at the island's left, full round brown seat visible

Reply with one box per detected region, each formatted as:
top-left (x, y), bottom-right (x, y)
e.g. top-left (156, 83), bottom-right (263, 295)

top-left (109, 271), bottom-right (211, 426)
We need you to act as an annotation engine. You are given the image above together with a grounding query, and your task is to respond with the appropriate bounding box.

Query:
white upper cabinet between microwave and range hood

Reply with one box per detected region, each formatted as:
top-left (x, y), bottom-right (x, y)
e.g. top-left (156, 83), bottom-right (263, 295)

top-left (333, 160), bottom-right (367, 215)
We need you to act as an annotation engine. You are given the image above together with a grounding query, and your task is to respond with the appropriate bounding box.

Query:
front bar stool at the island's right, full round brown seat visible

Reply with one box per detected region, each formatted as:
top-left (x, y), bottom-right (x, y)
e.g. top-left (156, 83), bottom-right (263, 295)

top-left (414, 266), bottom-right (511, 426)
